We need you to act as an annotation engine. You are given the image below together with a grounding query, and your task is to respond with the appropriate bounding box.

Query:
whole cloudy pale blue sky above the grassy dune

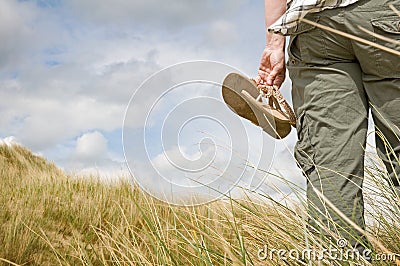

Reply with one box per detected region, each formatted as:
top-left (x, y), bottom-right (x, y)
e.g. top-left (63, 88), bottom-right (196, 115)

top-left (0, 0), bottom-right (310, 204)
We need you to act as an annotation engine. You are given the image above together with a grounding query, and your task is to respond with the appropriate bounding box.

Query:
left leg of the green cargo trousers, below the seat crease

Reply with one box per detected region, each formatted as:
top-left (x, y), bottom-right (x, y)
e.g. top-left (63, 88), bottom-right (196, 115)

top-left (289, 61), bottom-right (368, 248)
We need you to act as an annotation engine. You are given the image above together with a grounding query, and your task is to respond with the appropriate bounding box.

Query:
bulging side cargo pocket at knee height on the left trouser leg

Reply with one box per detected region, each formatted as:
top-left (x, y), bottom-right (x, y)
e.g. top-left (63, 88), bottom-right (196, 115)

top-left (294, 112), bottom-right (315, 175)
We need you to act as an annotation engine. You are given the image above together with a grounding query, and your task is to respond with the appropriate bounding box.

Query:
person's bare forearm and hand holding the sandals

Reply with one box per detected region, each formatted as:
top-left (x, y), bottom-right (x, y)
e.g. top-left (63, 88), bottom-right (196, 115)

top-left (257, 0), bottom-right (286, 87)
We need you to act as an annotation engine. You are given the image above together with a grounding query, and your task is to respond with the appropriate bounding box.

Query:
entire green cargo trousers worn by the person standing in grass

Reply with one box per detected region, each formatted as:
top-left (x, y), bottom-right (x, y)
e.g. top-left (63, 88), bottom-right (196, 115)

top-left (287, 0), bottom-right (400, 249)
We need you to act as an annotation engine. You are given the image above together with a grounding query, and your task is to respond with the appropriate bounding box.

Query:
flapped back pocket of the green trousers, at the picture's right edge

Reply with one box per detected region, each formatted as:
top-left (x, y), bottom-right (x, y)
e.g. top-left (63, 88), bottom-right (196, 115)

top-left (371, 15), bottom-right (400, 78)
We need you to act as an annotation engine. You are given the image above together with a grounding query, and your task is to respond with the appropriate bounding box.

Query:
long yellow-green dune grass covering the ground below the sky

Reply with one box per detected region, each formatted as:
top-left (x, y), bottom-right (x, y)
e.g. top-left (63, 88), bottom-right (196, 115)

top-left (0, 145), bottom-right (400, 265)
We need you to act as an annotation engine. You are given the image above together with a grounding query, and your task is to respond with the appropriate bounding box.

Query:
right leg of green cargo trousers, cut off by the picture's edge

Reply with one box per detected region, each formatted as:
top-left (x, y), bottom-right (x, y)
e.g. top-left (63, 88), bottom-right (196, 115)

top-left (347, 0), bottom-right (400, 193)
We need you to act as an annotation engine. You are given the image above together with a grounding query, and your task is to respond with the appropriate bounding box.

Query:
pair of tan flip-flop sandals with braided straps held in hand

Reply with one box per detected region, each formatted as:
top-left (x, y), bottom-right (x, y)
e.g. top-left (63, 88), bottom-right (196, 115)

top-left (222, 73), bottom-right (296, 139)
